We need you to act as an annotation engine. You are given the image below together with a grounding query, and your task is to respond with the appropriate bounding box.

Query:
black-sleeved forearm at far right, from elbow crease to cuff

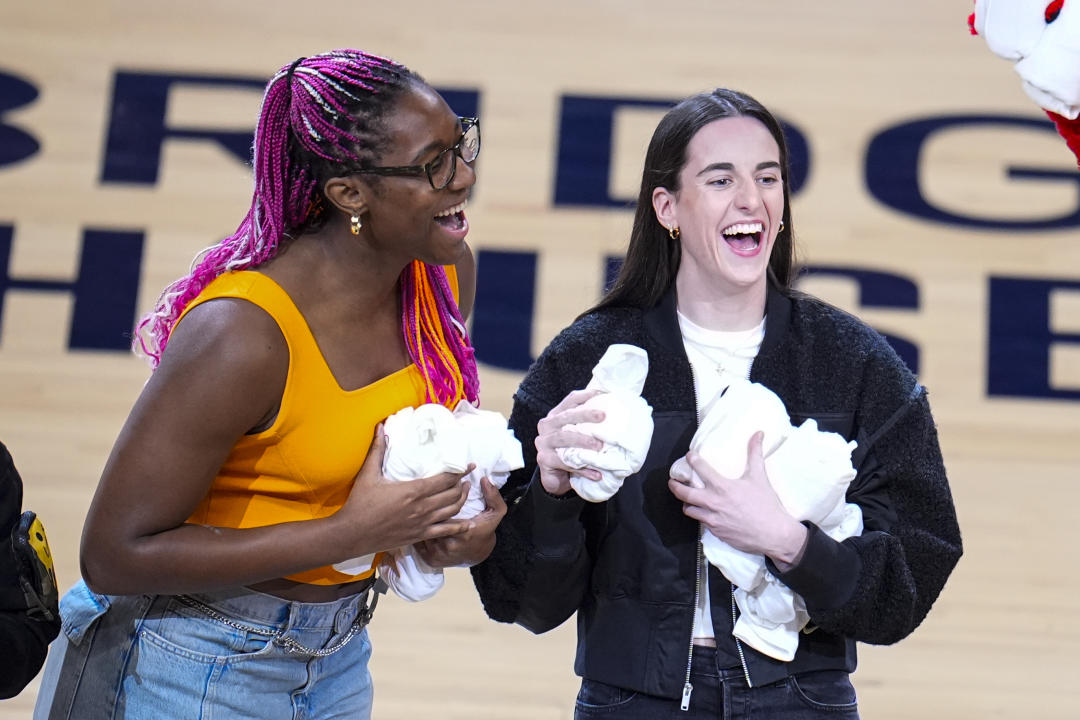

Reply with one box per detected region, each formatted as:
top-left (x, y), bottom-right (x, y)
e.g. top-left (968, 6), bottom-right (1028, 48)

top-left (778, 397), bottom-right (962, 643)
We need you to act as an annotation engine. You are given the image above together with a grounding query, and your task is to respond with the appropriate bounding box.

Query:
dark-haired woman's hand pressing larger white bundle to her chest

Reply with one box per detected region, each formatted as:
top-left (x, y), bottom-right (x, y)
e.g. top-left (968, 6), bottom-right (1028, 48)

top-left (667, 432), bottom-right (807, 569)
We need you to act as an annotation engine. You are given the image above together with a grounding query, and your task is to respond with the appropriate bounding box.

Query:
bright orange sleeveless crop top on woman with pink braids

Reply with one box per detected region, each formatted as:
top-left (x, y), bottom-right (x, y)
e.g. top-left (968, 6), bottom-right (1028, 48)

top-left (180, 266), bottom-right (458, 585)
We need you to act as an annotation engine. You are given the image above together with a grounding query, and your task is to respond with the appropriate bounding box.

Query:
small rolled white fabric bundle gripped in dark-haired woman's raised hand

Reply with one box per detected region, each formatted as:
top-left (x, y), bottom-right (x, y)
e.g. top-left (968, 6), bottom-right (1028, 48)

top-left (558, 343), bottom-right (652, 502)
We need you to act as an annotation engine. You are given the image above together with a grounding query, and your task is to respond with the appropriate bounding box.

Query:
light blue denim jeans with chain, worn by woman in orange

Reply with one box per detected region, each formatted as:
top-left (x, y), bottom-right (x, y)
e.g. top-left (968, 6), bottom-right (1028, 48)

top-left (33, 581), bottom-right (373, 720)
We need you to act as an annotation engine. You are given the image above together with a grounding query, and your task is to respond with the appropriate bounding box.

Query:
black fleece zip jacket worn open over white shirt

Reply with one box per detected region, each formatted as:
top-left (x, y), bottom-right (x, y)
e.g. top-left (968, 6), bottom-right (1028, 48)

top-left (472, 288), bottom-right (961, 698)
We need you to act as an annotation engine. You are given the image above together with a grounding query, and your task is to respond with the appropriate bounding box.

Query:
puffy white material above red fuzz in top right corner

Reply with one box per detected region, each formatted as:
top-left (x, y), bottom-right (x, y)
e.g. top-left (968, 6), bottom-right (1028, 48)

top-left (975, 0), bottom-right (1080, 120)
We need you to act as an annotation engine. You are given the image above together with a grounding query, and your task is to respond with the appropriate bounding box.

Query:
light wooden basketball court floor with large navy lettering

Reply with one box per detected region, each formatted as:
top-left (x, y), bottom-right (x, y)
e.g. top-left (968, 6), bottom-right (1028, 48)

top-left (0, 0), bottom-right (1080, 720)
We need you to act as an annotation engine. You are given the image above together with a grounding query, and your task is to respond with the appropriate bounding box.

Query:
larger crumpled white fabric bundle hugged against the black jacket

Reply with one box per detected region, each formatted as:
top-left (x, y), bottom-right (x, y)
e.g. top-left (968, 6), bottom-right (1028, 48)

top-left (672, 380), bottom-right (863, 662)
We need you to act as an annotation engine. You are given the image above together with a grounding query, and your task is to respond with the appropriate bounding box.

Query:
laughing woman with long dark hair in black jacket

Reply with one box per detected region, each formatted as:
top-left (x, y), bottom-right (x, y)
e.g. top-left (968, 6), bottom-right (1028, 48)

top-left (473, 90), bottom-right (961, 718)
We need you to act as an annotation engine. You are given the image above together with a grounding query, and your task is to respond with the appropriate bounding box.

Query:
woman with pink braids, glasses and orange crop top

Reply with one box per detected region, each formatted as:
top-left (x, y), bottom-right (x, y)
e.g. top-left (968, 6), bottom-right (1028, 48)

top-left (35, 50), bottom-right (505, 720)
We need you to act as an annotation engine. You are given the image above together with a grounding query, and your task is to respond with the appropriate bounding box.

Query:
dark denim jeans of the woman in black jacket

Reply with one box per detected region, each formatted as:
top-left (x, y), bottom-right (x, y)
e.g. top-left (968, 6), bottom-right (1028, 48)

top-left (573, 647), bottom-right (859, 720)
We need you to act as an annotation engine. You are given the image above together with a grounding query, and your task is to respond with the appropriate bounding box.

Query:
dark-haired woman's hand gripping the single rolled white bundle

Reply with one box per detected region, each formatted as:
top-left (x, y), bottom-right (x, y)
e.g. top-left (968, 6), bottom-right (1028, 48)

top-left (536, 390), bottom-right (604, 495)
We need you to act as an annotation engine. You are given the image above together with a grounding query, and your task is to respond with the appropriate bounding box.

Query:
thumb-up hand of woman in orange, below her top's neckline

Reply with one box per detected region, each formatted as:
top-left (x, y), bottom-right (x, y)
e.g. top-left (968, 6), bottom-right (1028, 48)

top-left (334, 423), bottom-right (472, 559)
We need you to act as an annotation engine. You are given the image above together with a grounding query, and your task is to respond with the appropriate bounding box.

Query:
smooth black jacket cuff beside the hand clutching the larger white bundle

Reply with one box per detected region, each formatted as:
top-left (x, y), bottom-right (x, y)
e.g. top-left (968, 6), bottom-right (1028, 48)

top-left (766, 522), bottom-right (863, 610)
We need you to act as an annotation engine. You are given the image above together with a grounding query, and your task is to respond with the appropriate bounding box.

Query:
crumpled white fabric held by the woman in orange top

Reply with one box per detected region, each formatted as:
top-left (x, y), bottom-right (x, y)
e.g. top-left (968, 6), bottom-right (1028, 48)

top-left (334, 400), bottom-right (525, 602)
